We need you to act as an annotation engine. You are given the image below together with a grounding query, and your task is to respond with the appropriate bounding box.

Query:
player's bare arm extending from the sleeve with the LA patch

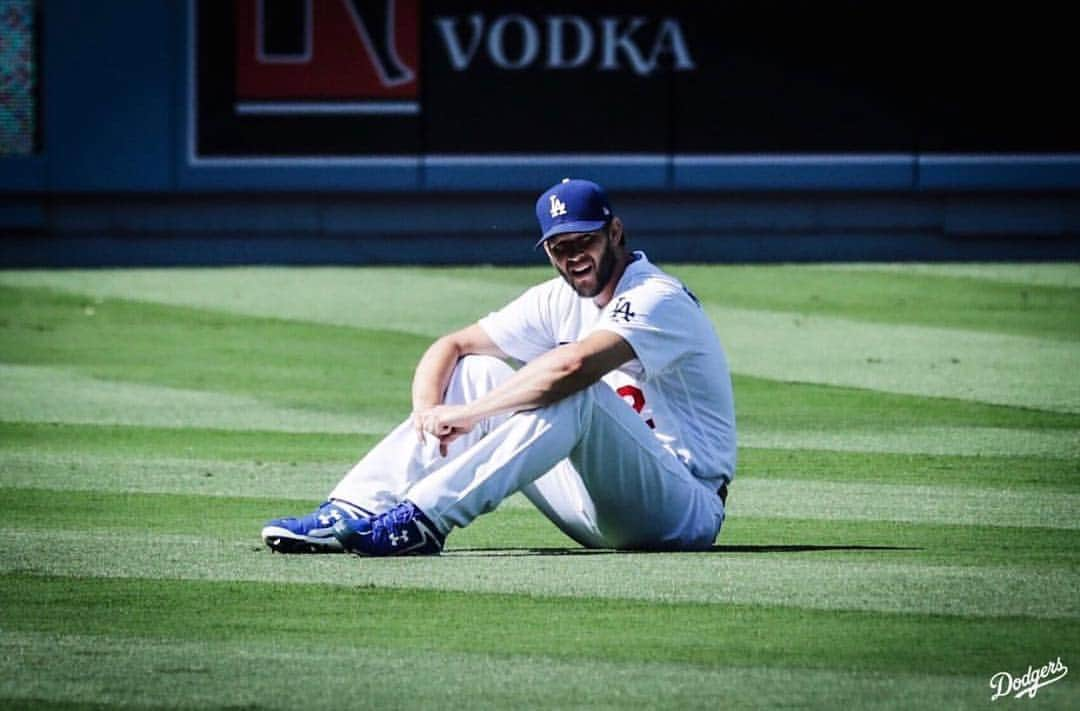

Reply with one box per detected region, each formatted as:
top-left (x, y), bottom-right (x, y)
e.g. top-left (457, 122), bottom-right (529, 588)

top-left (417, 330), bottom-right (634, 452)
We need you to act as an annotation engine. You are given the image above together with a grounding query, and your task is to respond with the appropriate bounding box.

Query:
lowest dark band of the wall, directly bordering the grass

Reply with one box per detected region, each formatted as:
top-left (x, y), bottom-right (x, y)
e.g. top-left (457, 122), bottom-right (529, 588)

top-left (8, 232), bottom-right (1080, 269)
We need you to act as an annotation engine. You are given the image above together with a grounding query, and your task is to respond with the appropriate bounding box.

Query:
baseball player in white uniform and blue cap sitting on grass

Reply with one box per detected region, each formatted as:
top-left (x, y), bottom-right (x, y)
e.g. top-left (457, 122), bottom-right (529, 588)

top-left (262, 179), bottom-right (735, 555)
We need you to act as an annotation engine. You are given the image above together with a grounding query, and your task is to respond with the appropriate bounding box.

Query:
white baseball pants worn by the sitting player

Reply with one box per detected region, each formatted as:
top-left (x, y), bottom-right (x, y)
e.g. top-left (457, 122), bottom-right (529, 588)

top-left (329, 356), bottom-right (724, 550)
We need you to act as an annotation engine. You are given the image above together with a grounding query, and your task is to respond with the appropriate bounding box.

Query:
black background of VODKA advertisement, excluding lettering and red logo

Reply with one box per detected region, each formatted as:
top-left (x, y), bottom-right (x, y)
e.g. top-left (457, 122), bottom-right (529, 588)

top-left (198, 0), bottom-right (1080, 156)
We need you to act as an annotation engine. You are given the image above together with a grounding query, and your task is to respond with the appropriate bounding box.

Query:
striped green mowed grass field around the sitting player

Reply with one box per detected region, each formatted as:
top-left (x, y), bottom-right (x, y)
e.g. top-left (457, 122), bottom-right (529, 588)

top-left (0, 264), bottom-right (1080, 709)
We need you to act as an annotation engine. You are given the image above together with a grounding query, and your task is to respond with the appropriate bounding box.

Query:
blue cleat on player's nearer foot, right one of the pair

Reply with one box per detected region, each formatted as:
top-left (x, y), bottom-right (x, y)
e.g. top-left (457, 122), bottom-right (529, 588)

top-left (334, 501), bottom-right (446, 555)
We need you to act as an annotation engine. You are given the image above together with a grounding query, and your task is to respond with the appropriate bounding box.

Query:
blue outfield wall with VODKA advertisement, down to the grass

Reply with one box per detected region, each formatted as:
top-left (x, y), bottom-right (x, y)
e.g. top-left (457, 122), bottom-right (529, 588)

top-left (0, 0), bottom-right (1080, 266)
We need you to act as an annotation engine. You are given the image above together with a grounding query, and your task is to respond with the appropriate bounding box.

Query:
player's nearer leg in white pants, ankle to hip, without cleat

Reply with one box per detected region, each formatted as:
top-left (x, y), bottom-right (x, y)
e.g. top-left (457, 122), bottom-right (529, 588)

top-left (406, 384), bottom-right (724, 550)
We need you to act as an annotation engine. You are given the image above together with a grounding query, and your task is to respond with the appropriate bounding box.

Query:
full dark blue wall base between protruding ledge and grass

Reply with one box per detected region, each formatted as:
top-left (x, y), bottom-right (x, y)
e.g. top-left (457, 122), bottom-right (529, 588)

top-left (0, 191), bottom-right (1080, 267)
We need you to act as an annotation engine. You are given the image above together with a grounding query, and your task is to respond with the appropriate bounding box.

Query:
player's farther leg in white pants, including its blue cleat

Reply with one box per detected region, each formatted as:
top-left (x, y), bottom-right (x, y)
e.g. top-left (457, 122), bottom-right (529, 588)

top-left (262, 357), bottom-right (513, 553)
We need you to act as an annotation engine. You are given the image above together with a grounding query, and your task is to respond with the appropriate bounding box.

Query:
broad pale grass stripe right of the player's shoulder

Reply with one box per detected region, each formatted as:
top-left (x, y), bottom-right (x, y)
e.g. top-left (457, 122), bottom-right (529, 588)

top-left (706, 306), bottom-right (1080, 413)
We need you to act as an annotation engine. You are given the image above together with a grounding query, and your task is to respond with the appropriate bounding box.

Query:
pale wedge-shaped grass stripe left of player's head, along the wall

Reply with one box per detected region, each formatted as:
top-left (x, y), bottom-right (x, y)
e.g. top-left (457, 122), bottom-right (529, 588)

top-left (0, 267), bottom-right (524, 340)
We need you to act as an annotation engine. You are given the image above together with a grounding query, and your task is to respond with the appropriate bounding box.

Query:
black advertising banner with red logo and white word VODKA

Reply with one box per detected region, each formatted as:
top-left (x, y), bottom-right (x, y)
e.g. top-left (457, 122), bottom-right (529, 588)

top-left (191, 0), bottom-right (1080, 158)
